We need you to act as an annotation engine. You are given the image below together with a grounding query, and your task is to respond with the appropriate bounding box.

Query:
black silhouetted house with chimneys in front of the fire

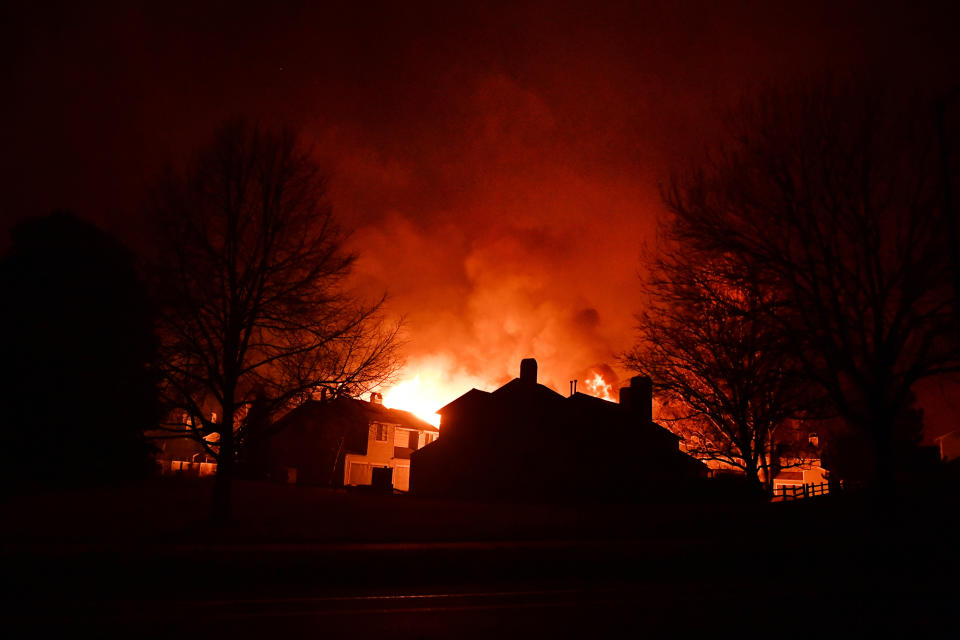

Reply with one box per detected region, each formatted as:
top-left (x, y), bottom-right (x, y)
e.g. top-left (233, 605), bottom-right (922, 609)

top-left (410, 359), bottom-right (707, 500)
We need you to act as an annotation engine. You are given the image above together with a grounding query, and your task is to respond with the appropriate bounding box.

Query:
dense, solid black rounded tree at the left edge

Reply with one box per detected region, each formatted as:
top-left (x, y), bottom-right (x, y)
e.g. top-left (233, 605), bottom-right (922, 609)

top-left (0, 213), bottom-right (158, 486)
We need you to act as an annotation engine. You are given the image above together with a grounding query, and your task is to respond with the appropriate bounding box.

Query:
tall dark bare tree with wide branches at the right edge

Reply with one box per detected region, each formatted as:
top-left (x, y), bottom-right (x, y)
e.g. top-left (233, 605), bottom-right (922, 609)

top-left (666, 79), bottom-right (960, 489)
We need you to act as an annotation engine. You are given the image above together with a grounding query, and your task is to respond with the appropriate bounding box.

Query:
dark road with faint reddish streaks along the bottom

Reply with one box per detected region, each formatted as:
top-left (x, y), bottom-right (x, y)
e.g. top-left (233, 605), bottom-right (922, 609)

top-left (5, 539), bottom-right (956, 638)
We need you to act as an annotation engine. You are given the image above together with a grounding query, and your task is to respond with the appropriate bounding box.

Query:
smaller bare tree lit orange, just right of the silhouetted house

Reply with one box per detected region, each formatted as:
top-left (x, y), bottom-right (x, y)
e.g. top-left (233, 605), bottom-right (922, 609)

top-left (622, 242), bottom-right (807, 491)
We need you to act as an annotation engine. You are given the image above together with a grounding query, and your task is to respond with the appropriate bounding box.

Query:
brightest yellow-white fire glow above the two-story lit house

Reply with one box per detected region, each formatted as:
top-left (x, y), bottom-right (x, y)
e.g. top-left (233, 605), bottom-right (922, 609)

top-left (383, 358), bottom-right (490, 427)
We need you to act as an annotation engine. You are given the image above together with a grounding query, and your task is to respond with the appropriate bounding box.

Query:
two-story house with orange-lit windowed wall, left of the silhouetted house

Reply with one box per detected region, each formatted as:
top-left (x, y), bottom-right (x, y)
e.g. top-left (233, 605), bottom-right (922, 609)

top-left (261, 393), bottom-right (440, 491)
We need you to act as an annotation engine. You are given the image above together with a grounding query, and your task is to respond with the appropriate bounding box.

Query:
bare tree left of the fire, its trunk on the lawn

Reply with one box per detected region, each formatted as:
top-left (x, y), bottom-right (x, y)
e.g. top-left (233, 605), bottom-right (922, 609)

top-left (153, 122), bottom-right (398, 520)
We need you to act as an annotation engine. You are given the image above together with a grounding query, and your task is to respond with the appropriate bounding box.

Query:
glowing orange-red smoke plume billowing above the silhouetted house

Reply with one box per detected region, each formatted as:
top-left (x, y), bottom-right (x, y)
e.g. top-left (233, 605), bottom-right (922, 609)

top-left (312, 77), bottom-right (659, 416)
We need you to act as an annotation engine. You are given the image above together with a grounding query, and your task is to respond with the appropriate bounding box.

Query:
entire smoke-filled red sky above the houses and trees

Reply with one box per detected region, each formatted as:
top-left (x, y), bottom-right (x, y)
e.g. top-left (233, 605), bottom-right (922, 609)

top-left (0, 0), bottom-right (958, 430)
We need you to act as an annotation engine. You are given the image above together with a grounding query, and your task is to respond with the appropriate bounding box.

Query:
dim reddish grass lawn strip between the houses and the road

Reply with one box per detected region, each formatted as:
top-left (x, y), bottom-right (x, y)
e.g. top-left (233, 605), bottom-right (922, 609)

top-left (0, 478), bottom-right (828, 545)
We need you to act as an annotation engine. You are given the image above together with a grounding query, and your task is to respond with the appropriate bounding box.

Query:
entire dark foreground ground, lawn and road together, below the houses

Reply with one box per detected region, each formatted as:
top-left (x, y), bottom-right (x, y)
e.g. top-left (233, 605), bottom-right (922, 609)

top-left (2, 482), bottom-right (960, 638)
